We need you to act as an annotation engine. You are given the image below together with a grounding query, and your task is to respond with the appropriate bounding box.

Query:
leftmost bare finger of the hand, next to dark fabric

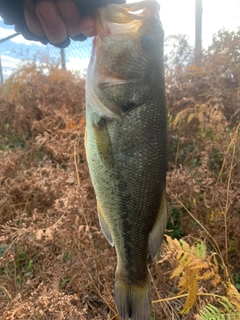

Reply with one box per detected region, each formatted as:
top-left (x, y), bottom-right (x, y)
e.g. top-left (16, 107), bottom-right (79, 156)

top-left (23, 0), bottom-right (45, 37)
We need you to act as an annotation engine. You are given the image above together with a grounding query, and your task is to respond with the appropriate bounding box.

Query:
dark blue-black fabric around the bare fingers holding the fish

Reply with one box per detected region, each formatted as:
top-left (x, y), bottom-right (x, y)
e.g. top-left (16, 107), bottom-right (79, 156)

top-left (0, 0), bottom-right (126, 48)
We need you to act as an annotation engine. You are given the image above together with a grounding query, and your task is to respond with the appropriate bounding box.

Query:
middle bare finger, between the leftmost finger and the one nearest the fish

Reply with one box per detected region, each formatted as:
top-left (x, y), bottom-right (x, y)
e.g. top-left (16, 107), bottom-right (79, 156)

top-left (36, 0), bottom-right (68, 43)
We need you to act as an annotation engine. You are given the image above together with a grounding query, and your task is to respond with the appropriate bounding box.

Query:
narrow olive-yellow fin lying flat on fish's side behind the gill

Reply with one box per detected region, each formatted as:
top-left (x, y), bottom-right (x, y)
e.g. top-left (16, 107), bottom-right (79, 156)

top-left (92, 117), bottom-right (114, 169)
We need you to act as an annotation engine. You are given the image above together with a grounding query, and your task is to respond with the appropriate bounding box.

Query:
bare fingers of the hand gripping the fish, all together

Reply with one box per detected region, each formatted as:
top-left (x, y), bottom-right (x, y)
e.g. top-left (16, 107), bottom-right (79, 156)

top-left (23, 0), bottom-right (95, 44)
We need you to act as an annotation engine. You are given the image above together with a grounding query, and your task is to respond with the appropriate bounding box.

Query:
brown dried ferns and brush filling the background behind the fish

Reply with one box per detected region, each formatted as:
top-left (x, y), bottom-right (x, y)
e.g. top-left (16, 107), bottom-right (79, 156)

top-left (0, 30), bottom-right (240, 320)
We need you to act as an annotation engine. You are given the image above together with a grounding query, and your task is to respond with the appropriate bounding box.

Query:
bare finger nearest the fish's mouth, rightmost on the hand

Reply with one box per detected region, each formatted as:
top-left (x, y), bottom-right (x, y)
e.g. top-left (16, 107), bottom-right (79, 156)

top-left (56, 0), bottom-right (94, 38)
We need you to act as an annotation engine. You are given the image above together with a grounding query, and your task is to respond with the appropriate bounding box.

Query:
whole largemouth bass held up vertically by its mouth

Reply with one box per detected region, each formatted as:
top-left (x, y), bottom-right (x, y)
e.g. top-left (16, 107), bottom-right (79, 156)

top-left (85, 0), bottom-right (167, 320)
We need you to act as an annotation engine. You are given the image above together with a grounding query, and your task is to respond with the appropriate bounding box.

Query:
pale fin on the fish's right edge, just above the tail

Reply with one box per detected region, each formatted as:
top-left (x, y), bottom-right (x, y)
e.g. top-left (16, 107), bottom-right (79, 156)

top-left (148, 190), bottom-right (167, 259)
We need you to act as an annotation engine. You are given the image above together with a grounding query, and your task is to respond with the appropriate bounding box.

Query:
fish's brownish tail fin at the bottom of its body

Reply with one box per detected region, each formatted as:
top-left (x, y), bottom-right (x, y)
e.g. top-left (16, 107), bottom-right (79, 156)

top-left (114, 272), bottom-right (151, 320)
